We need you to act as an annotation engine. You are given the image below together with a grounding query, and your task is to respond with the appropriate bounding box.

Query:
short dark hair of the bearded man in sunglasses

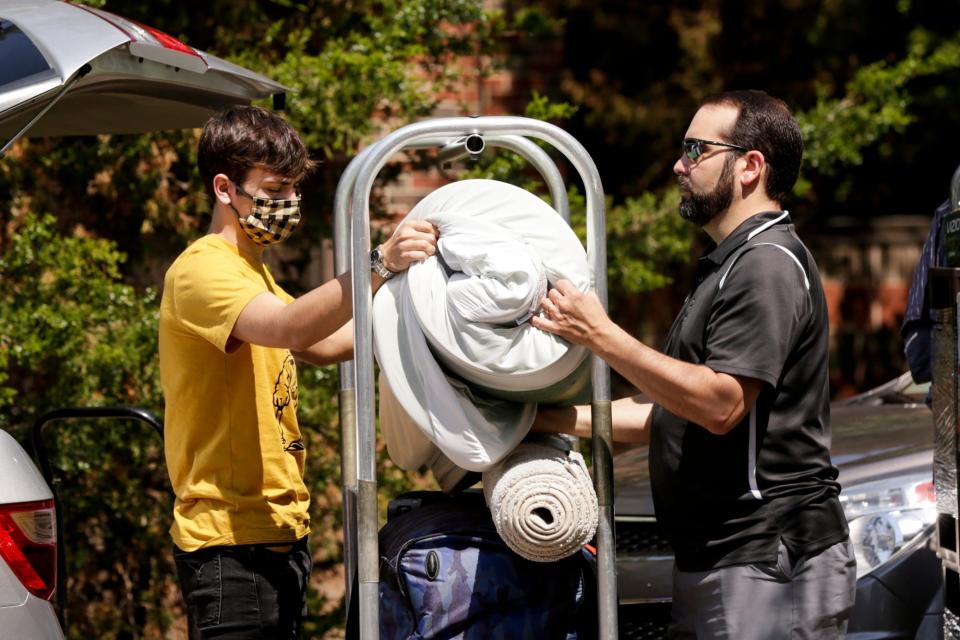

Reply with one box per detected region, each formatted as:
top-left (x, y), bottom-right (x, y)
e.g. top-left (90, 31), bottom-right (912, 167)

top-left (700, 90), bottom-right (803, 206)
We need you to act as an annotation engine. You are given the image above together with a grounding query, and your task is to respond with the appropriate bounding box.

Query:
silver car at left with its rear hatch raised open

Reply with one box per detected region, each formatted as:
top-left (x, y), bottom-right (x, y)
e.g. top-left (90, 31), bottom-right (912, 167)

top-left (0, 0), bottom-right (286, 640)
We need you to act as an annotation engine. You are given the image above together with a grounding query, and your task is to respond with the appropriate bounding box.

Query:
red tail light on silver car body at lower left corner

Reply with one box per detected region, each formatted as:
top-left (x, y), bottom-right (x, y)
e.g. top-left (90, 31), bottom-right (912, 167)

top-left (0, 500), bottom-right (57, 600)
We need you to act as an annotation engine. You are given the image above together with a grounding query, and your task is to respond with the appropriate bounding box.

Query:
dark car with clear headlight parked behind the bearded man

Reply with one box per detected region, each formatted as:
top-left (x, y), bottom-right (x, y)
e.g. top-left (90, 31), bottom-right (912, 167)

top-left (614, 374), bottom-right (943, 640)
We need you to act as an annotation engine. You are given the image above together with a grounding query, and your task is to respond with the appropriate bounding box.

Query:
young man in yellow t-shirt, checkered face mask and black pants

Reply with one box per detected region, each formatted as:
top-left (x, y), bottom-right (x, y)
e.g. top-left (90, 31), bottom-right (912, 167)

top-left (160, 106), bottom-right (436, 638)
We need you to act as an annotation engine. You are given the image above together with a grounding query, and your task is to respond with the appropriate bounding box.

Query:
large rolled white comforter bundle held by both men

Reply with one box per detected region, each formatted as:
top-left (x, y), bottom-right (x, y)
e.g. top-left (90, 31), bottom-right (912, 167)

top-left (373, 180), bottom-right (590, 476)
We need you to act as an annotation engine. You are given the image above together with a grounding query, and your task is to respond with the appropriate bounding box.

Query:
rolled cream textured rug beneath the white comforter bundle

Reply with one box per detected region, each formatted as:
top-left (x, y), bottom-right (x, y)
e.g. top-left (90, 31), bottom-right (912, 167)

top-left (483, 443), bottom-right (599, 562)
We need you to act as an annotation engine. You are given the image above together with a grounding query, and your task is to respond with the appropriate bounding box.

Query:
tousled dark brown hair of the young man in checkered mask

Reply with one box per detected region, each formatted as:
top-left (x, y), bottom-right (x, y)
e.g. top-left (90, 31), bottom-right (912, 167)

top-left (197, 106), bottom-right (316, 197)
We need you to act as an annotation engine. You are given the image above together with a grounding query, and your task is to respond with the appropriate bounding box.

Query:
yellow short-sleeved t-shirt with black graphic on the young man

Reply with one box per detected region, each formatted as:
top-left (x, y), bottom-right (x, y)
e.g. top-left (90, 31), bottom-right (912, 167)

top-left (160, 235), bottom-right (310, 551)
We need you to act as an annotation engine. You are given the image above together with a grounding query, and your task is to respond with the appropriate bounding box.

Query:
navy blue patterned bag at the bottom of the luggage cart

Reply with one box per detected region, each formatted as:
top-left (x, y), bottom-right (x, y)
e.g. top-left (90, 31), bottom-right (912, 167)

top-left (380, 491), bottom-right (597, 640)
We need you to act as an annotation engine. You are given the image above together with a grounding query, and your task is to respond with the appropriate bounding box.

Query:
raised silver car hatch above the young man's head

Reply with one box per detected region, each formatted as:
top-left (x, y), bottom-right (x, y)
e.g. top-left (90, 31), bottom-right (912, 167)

top-left (0, 0), bottom-right (287, 152)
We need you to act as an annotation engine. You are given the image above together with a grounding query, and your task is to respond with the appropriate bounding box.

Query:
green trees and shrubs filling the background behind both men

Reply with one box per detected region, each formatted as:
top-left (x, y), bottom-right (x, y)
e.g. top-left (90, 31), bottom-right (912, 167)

top-left (0, 0), bottom-right (960, 638)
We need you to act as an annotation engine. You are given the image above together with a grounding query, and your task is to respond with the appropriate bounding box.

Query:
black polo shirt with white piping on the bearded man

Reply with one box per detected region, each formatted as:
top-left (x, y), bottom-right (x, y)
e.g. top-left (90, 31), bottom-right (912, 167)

top-left (650, 211), bottom-right (847, 571)
